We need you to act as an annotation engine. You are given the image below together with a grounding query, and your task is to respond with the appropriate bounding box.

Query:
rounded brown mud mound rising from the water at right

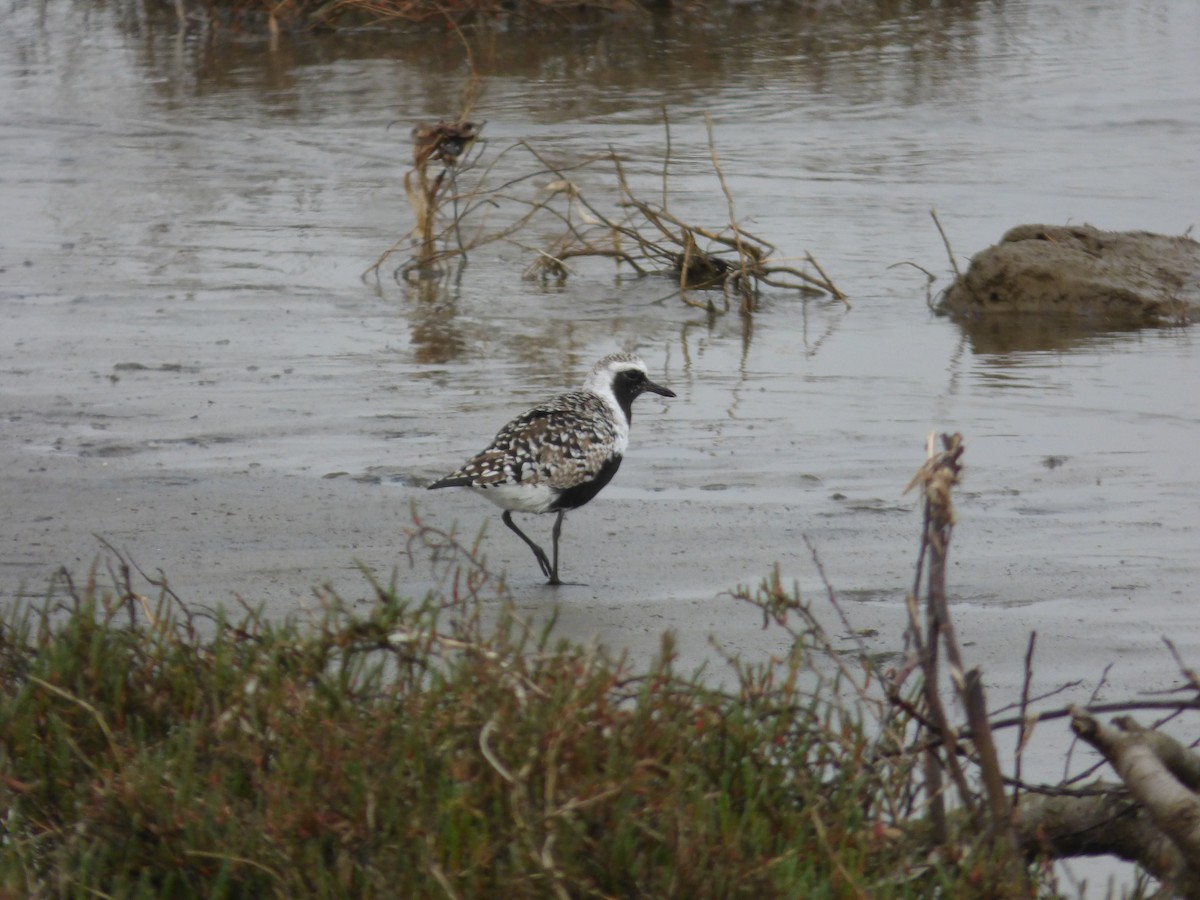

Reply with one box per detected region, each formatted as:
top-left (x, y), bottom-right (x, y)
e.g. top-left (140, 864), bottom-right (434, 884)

top-left (941, 224), bottom-right (1200, 325)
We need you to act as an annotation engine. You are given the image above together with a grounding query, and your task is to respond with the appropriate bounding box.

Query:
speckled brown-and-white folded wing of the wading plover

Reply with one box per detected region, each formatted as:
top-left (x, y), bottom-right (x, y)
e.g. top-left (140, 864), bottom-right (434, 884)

top-left (443, 391), bottom-right (617, 491)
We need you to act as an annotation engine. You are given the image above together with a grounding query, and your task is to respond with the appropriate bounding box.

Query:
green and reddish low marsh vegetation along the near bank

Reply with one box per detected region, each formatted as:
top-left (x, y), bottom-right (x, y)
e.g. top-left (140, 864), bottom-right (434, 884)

top-left (0, 518), bottom-right (1051, 898)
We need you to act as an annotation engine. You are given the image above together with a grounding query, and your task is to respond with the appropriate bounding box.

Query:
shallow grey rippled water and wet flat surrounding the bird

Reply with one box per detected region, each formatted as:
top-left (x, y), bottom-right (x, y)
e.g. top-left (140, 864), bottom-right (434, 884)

top-left (0, 0), bottom-right (1200, 844)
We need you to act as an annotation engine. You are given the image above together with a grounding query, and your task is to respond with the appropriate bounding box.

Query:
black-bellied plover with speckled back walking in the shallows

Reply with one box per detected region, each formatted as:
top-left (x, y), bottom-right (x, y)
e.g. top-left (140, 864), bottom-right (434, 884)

top-left (430, 353), bottom-right (674, 584)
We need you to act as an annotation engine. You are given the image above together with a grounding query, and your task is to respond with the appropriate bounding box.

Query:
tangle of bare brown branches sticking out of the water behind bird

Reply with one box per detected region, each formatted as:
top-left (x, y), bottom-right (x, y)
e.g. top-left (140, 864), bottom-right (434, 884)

top-left (368, 120), bottom-right (848, 313)
